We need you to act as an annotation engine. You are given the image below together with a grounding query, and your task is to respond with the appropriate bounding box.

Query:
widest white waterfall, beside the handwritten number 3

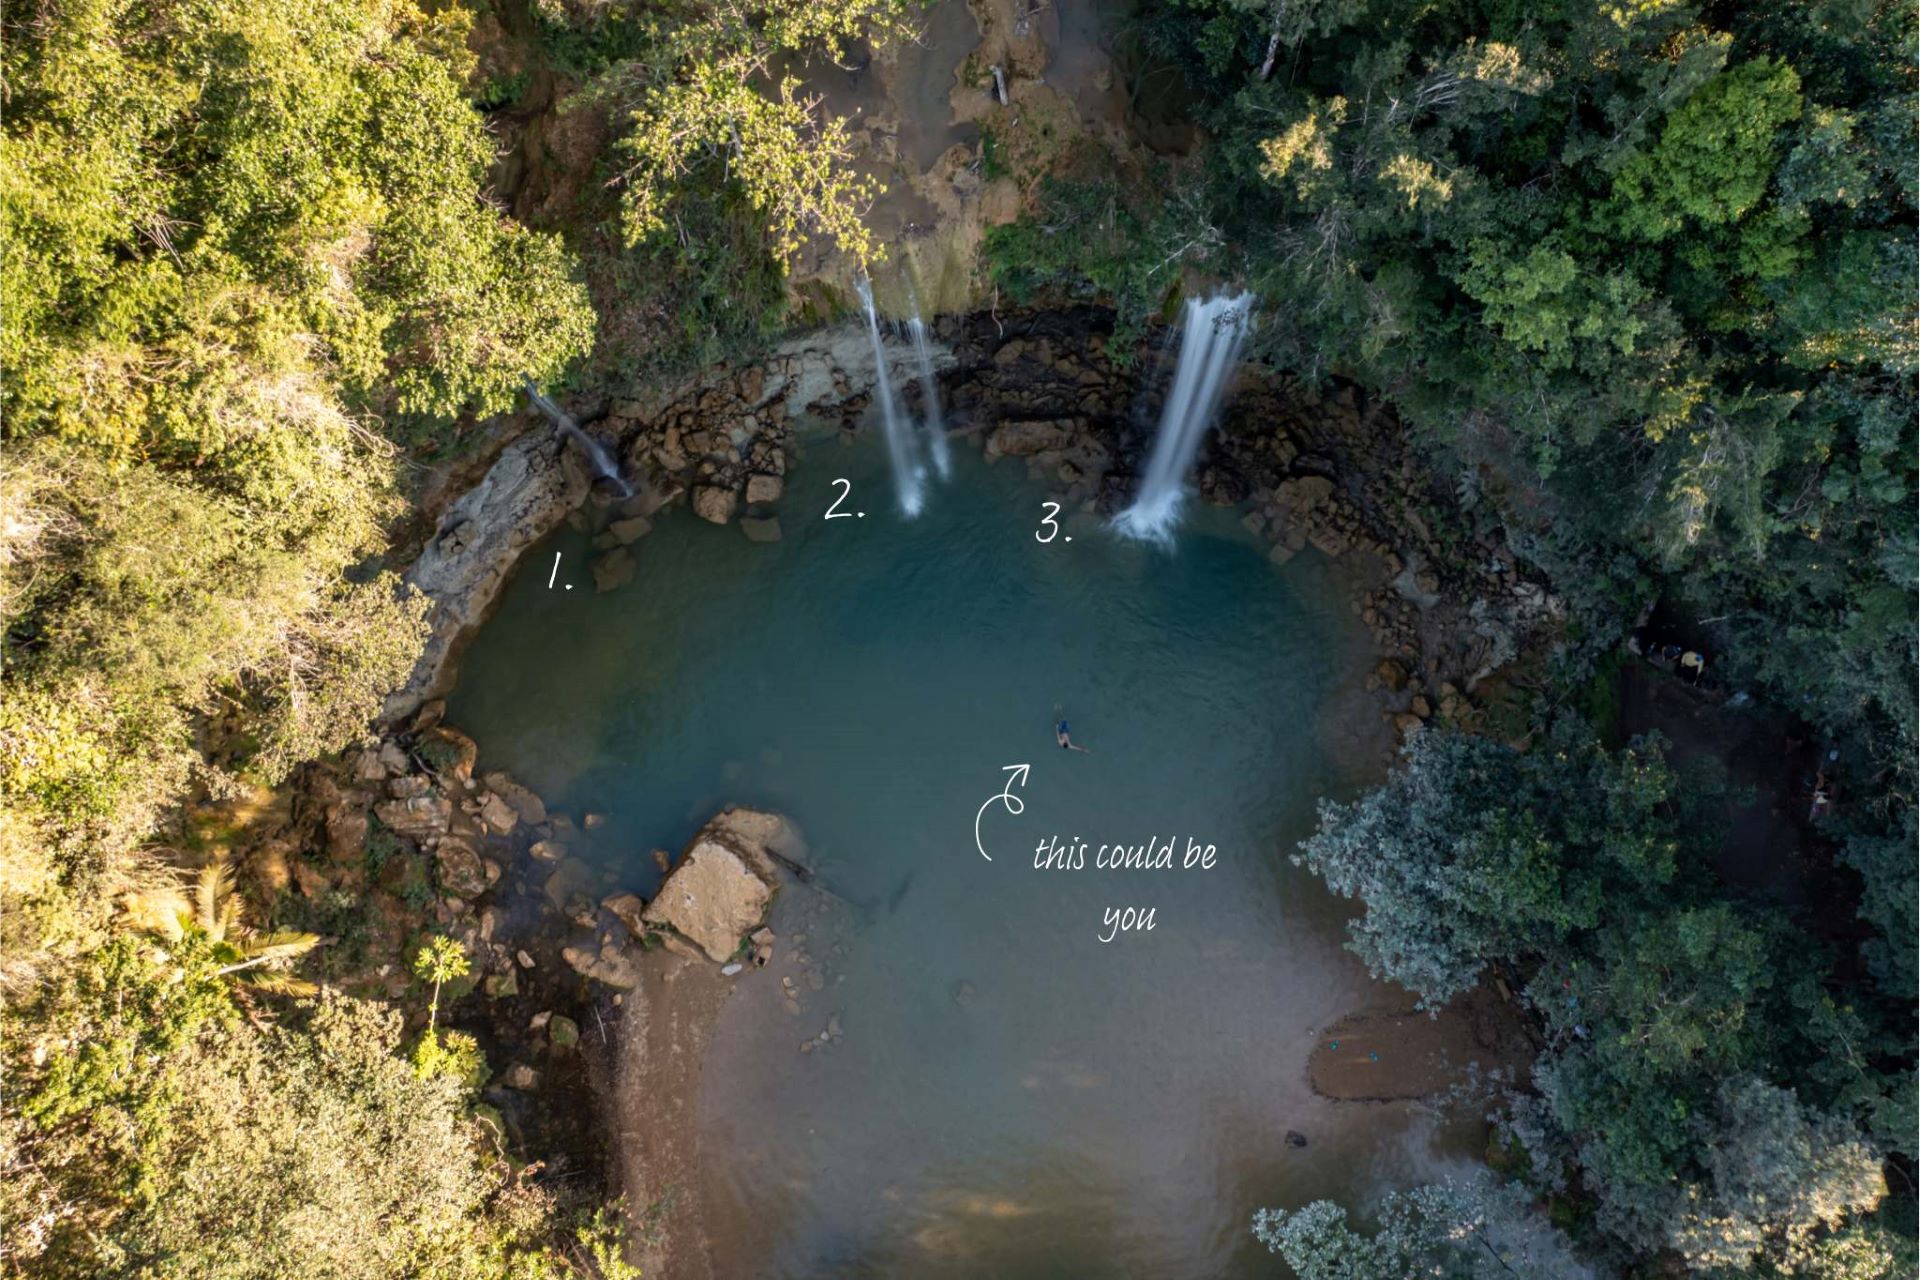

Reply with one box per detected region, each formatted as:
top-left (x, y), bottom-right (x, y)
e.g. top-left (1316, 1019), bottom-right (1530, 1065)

top-left (1114, 294), bottom-right (1254, 539)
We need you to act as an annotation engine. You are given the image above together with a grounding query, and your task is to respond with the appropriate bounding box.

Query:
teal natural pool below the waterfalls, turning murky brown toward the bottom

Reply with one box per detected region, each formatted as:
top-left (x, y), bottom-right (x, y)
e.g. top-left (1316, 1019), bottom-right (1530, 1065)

top-left (451, 436), bottom-right (1466, 1278)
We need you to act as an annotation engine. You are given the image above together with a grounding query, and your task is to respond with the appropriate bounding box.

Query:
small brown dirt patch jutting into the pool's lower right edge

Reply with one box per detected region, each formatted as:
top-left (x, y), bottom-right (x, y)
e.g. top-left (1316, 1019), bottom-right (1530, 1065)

top-left (1308, 986), bottom-right (1534, 1102)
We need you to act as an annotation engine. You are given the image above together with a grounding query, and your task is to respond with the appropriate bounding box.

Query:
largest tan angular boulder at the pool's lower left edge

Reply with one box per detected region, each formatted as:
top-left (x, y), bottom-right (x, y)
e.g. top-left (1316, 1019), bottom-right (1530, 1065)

top-left (641, 810), bottom-right (789, 963)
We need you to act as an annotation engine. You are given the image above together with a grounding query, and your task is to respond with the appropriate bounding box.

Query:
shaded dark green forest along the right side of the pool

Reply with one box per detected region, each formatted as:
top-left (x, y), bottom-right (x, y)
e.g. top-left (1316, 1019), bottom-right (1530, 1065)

top-left (991, 0), bottom-right (1920, 1278)
